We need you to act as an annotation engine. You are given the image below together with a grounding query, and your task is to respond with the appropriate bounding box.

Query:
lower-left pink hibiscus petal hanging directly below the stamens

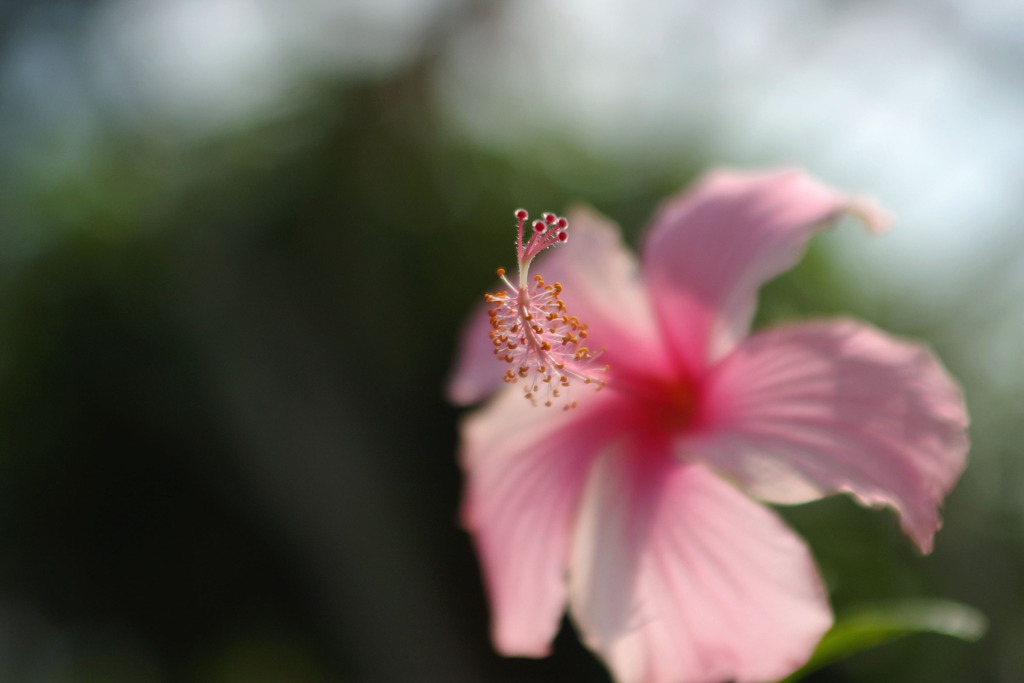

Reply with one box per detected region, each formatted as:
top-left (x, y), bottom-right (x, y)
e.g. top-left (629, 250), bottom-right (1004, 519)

top-left (461, 390), bottom-right (615, 656)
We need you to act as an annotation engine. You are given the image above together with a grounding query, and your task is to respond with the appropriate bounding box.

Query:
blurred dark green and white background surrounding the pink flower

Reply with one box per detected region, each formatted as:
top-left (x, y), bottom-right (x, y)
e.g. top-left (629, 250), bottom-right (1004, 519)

top-left (0, 0), bottom-right (1024, 683)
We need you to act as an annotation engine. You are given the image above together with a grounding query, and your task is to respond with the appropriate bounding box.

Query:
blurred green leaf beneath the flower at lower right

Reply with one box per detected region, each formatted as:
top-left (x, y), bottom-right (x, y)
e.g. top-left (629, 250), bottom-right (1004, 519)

top-left (779, 599), bottom-right (988, 683)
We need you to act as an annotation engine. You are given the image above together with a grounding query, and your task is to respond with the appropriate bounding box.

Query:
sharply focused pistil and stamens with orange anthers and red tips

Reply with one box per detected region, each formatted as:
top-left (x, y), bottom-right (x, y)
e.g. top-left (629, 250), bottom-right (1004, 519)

top-left (484, 209), bottom-right (607, 410)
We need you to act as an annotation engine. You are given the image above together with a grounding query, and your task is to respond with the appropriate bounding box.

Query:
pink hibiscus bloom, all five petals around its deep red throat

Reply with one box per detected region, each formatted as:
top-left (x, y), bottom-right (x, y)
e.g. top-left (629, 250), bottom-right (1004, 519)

top-left (450, 170), bottom-right (968, 683)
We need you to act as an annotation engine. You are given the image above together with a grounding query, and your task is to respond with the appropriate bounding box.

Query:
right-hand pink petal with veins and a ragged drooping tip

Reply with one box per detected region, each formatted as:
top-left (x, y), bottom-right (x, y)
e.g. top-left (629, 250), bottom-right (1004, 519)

top-left (685, 321), bottom-right (968, 552)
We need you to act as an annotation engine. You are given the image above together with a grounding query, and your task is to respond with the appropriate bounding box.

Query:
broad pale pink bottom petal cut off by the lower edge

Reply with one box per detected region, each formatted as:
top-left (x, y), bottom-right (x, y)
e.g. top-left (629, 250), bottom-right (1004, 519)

top-left (569, 444), bottom-right (831, 683)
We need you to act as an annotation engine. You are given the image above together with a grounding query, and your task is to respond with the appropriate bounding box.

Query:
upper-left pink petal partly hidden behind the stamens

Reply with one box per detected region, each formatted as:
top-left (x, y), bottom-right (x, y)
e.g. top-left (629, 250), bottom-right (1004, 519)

top-left (449, 209), bottom-right (668, 404)
